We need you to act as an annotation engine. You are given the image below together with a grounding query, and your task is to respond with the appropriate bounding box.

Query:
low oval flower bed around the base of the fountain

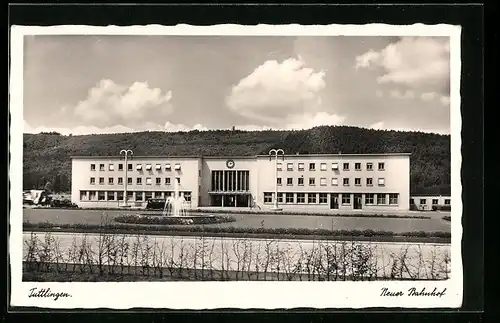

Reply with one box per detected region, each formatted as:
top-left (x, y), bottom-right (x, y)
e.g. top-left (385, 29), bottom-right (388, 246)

top-left (113, 214), bottom-right (236, 225)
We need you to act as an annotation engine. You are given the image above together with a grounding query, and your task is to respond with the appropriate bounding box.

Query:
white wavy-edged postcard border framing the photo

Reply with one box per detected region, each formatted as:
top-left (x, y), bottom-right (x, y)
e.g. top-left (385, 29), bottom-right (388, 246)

top-left (8, 24), bottom-right (463, 309)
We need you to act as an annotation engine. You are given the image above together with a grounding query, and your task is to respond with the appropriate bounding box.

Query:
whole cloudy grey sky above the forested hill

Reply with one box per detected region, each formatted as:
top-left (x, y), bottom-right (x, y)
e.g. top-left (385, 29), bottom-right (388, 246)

top-left (23, 35), bottom-right (450, 135)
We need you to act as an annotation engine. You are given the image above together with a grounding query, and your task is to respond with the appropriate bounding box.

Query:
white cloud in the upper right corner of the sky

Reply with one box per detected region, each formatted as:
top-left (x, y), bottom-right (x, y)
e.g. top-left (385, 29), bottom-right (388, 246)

top-left (355, 37), bottom-right (450, 95)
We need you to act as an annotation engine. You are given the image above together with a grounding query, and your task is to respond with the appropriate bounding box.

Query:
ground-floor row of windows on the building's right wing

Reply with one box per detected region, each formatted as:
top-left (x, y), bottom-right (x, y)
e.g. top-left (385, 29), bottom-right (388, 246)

top-left (264, 192), bottom-right (399, 205)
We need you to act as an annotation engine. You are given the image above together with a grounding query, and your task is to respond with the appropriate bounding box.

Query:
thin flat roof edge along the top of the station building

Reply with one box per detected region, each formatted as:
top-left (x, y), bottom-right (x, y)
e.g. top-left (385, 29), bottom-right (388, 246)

top-left (70, 153), bottom-right (411, 159)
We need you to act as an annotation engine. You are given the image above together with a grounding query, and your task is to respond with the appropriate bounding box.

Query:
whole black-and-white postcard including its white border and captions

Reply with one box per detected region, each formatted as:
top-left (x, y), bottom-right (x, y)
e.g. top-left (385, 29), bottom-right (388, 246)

top-left (10, 24), bottom-right (462, 309)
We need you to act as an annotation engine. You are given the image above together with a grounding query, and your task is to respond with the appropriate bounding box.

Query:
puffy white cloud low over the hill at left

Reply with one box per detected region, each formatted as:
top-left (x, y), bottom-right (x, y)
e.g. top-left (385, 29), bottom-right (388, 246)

top-left (74, 79), bottom-right (173, 128)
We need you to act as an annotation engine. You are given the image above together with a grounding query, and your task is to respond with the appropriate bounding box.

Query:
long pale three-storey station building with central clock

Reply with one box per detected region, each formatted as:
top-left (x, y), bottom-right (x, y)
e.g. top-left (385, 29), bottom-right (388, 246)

top-left (71, 154), bottom-right (410, 211)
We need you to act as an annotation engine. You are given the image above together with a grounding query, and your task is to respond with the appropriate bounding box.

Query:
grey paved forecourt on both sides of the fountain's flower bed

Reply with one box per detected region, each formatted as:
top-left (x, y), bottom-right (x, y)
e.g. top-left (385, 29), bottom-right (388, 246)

top-left (23, 209), bottom-right (451, 232)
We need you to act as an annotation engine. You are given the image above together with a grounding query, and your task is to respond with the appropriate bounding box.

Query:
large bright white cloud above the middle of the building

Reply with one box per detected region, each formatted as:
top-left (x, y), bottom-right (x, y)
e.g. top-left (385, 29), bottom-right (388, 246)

top-left (226, 57), bottom-right (326, 126)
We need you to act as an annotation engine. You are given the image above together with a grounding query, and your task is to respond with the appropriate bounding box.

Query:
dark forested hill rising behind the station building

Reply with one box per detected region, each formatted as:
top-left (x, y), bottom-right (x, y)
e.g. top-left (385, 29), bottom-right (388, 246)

top-left (23, 126), bottom-right (450, 194)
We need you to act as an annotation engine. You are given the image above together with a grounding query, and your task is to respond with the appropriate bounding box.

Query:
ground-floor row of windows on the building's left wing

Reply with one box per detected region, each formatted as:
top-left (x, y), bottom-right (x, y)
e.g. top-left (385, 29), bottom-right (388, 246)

top-left (80, 191), bottom-right (191, 202)
